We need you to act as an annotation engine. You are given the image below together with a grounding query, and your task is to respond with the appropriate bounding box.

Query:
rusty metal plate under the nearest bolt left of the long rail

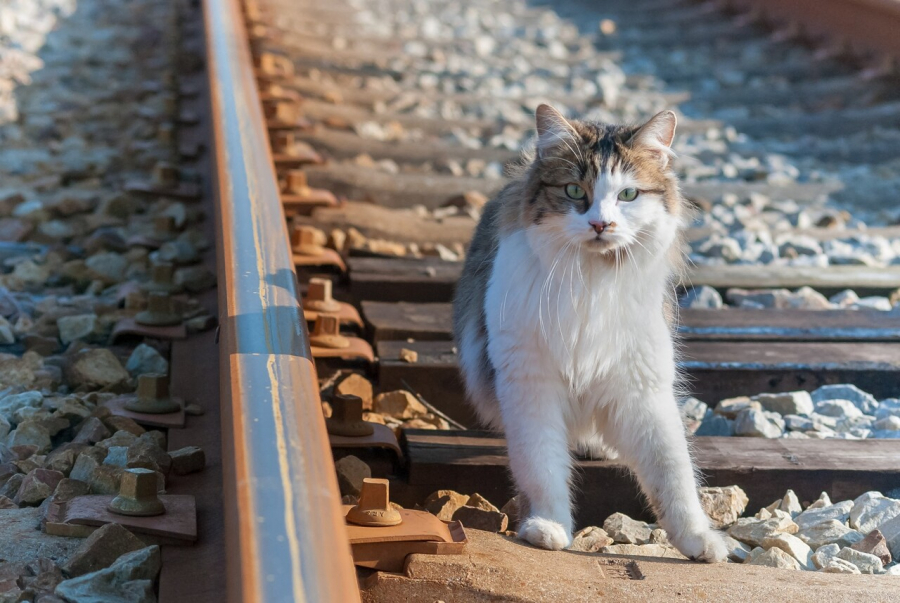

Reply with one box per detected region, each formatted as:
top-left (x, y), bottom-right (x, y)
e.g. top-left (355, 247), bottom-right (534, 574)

top-left (45, 494), bottom-right (197, 544)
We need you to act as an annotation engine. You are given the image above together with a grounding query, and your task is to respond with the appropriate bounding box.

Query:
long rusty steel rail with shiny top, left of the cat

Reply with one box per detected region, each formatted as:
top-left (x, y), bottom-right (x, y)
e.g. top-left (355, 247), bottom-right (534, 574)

top-left (198, 0), bottom-right (359, 603)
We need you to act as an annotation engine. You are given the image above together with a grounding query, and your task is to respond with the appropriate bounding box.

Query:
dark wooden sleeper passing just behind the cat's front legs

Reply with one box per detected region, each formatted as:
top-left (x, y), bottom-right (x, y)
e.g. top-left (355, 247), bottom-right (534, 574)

top-left (391, 430), bottom-right (900, 526)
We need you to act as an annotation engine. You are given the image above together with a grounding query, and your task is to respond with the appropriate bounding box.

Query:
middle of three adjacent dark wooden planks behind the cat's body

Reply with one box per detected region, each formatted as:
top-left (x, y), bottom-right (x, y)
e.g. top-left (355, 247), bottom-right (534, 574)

top-left (362, 301), bottom-right (900, 342)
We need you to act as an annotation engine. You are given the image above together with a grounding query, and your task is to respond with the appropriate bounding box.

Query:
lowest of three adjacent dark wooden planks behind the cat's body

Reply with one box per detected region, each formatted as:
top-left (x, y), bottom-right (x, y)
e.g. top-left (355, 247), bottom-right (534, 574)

top-left (377, 341), bottom-right (900, 425)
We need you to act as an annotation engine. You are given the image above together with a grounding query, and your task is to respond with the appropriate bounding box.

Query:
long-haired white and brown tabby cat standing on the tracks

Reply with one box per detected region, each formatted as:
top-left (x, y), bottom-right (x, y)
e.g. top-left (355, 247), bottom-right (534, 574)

top-left (453, 105), bottom-right (728, 562)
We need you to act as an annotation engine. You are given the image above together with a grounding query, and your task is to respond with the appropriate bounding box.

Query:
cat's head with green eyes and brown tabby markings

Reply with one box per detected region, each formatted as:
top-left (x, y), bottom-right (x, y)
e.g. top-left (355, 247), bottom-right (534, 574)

top-left (522, 105), bottom-right (686, 256)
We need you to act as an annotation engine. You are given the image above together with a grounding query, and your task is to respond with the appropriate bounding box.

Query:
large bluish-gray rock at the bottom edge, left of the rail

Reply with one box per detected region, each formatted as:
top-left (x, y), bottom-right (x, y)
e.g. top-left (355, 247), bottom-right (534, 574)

top-left (55, 545), bottom-right (160, 603)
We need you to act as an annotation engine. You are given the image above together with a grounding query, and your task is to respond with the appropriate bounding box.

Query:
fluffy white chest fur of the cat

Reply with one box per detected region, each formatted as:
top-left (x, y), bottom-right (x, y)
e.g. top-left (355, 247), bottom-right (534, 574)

top-left (485, 231), bottom-right (674, 426)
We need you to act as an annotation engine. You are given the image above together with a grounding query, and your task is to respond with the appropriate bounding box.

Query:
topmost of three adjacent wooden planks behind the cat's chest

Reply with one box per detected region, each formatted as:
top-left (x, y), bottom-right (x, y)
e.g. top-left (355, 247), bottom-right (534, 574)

top-left (349, 258), bottom-right (900, 302)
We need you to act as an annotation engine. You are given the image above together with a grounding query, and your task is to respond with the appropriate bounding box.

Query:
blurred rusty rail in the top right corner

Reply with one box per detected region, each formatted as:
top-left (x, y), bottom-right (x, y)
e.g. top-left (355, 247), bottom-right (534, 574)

top-left (728, 0), bottom-right (900, 58)
